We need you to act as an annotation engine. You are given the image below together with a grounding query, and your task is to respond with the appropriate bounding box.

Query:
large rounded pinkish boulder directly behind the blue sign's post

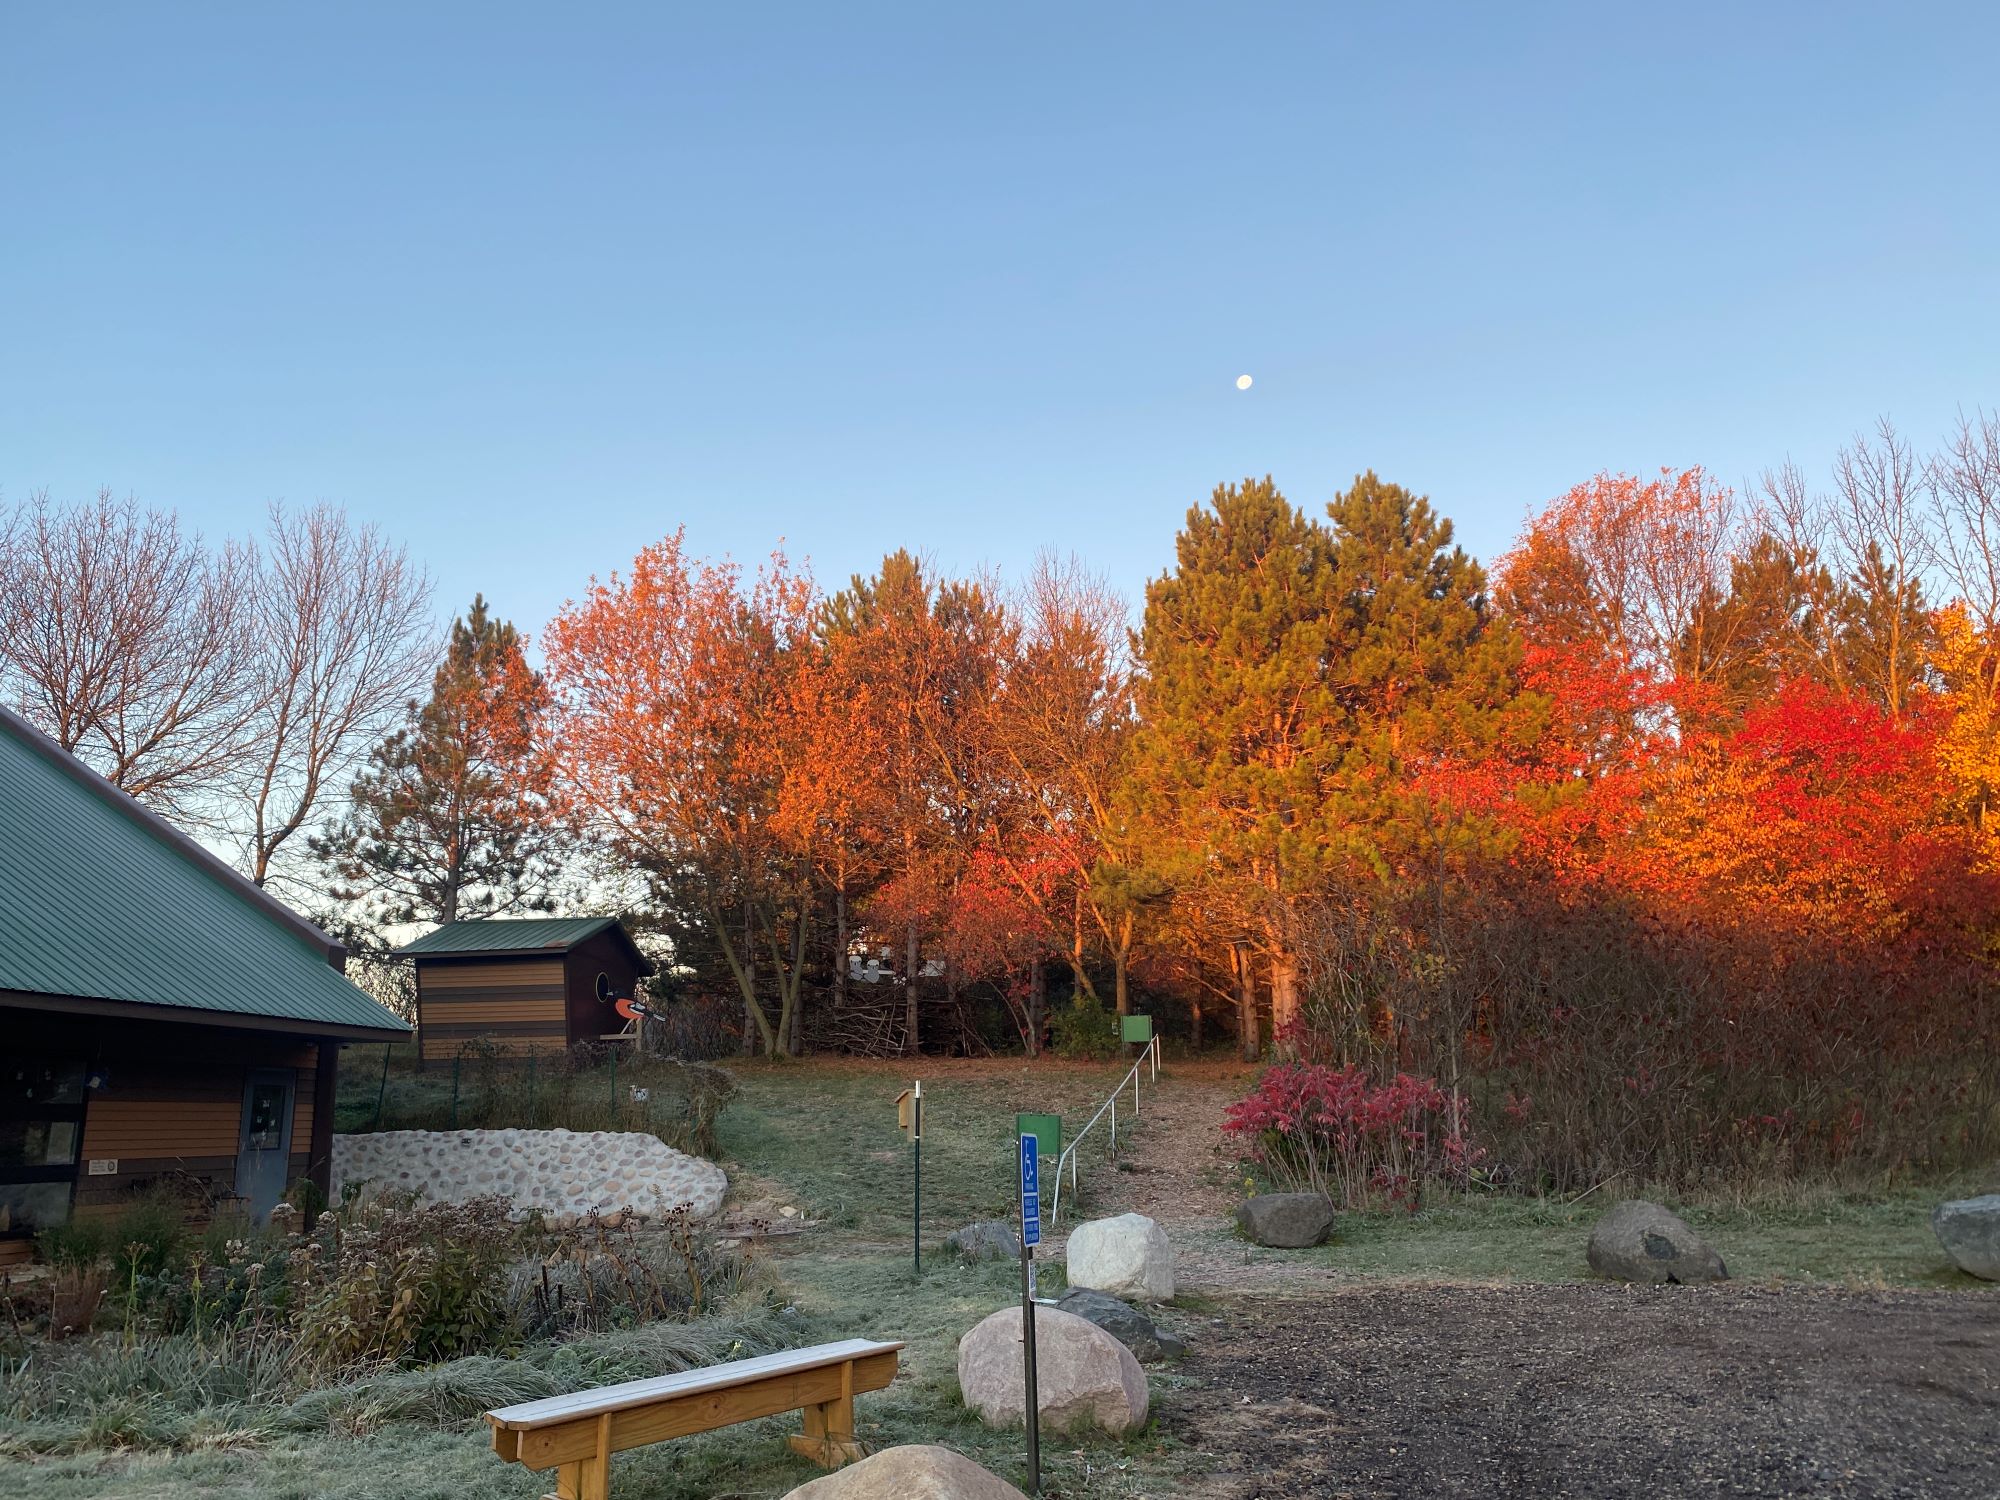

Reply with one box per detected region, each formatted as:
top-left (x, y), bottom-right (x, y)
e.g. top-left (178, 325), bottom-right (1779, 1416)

top-left (958, 1306), bottom-right (1148, 1436)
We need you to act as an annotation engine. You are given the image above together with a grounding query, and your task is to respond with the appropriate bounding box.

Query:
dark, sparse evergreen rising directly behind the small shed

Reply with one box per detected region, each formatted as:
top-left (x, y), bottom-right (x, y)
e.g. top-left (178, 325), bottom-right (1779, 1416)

top-left (314, 596), bottom-right (562, 924)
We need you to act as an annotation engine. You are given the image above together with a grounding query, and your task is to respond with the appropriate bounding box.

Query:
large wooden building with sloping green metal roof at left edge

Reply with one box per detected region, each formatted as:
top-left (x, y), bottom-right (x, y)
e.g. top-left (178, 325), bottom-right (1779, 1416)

top-left (0, 708), bottom-right (410, 1264)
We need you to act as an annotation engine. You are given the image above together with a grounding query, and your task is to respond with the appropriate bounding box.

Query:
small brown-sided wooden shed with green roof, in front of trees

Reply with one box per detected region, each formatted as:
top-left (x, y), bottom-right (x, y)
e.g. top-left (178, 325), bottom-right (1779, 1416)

top-left (396, 916), bottom-right (654, 1064)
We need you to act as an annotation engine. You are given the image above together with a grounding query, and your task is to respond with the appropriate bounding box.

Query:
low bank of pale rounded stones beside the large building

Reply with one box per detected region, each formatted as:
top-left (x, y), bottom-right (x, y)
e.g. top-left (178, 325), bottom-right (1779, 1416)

top-left (332, 1130), bottom-right (728, 1224)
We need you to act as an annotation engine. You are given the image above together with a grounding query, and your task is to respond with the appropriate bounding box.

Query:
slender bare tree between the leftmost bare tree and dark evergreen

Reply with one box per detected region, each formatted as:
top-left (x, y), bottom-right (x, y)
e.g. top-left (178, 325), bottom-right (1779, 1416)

top-left (242, 504), bottom-right (438, 886)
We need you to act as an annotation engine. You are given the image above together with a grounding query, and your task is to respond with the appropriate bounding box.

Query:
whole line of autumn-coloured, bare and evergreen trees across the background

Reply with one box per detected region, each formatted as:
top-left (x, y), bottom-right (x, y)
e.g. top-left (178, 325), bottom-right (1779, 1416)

top-left (11, 416), bottom-right (2000, 1172)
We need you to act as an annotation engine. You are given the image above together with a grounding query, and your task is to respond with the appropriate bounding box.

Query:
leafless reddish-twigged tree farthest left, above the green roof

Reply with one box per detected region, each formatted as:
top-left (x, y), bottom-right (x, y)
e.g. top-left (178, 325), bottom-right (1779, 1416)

top-left (0, 490), bottom-right (260, 826)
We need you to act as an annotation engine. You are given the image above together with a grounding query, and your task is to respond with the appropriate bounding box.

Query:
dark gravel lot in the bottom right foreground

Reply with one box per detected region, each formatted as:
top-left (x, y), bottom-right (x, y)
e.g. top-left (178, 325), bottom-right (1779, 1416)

top-left (1162, 1286), bottom-right (2000, 1500)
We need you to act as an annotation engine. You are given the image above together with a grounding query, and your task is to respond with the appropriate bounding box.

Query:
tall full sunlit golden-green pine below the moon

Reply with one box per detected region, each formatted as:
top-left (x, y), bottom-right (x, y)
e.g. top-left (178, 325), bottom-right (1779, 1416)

top-left (1134, 474), bottom-right (1534, 1028)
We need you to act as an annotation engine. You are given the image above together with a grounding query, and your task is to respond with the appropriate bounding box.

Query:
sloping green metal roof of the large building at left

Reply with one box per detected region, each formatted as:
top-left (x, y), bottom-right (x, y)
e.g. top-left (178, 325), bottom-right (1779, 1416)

top-left (0, 708), bottom-right (410, 1034)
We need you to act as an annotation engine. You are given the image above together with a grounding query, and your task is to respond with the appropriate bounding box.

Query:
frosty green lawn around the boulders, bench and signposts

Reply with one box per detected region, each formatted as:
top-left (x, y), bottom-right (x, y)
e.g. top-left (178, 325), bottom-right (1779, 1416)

top-left (0, 1048), bottom-right (1990, 1500)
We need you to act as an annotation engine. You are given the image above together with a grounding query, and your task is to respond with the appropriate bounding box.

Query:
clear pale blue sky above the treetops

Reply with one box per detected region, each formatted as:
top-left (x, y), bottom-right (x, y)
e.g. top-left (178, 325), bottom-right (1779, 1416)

top-left (0, 2), bottom-right (2000, 628)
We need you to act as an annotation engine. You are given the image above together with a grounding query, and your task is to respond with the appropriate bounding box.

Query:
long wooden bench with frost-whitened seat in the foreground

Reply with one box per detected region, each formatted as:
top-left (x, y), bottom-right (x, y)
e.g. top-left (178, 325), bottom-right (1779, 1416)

top-left (486, 1338), bottom-right (902, 1500)
